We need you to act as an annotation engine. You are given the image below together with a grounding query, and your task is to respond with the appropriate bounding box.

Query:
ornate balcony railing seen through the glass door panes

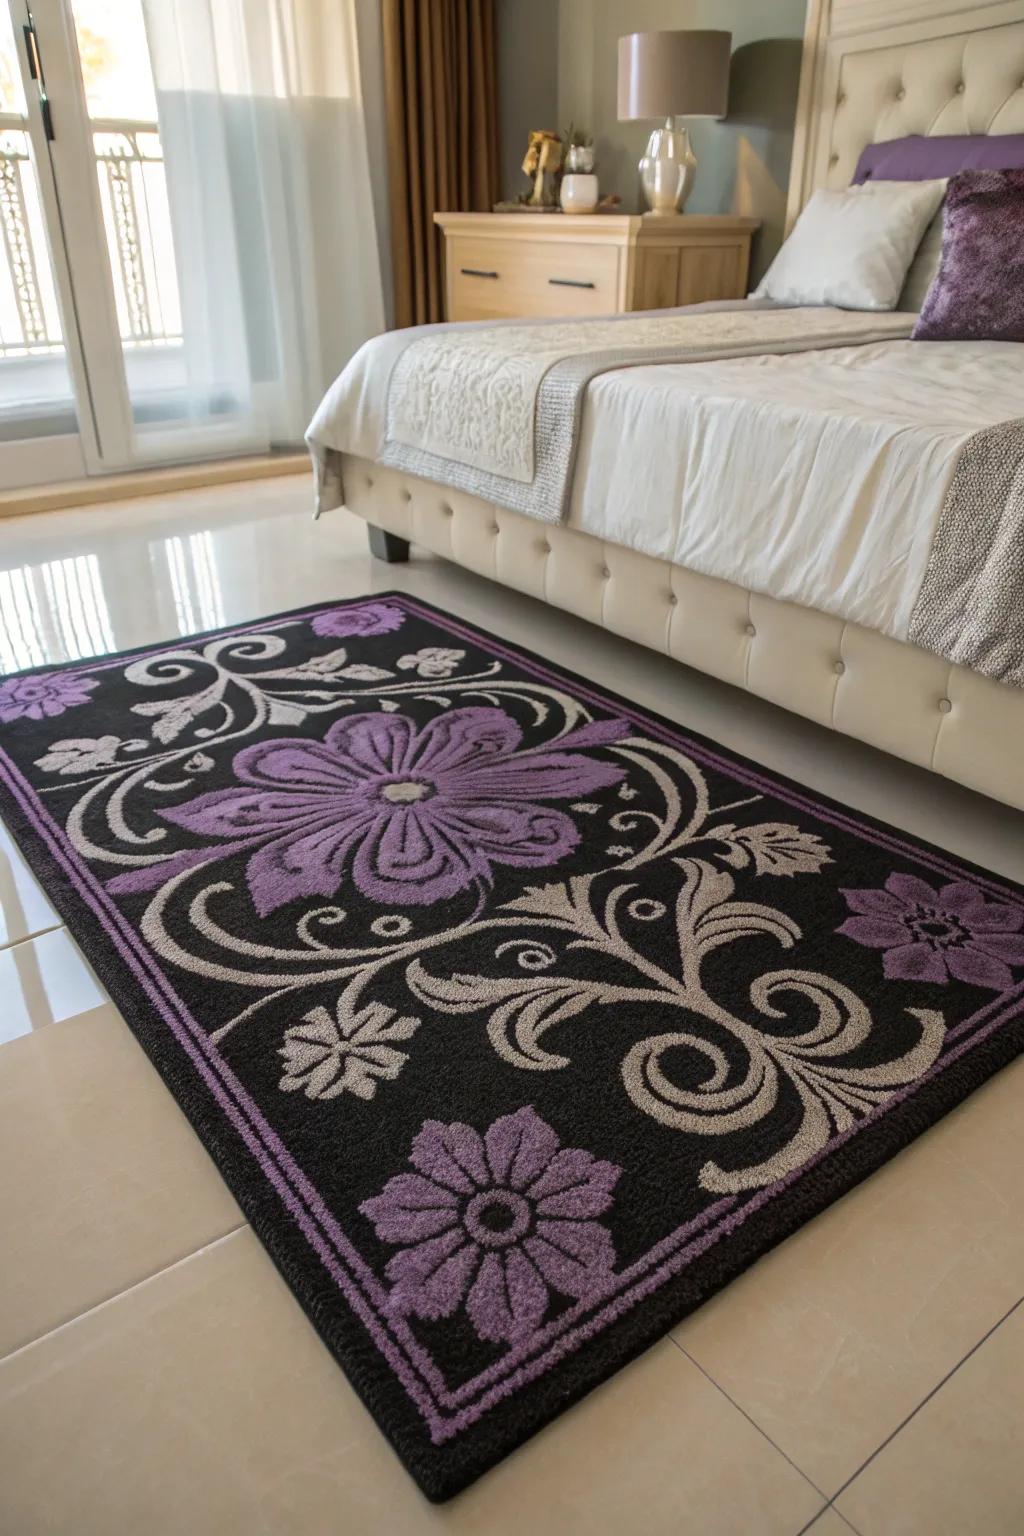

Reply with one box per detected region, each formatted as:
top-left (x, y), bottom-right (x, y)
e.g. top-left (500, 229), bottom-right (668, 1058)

top-left (0, 114), bottom-right (181, 359)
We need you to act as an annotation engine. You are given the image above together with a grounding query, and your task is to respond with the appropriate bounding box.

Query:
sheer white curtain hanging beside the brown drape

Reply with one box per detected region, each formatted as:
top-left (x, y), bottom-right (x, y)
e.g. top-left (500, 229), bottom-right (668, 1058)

top-left (144, 0), bottom-right (384, 449)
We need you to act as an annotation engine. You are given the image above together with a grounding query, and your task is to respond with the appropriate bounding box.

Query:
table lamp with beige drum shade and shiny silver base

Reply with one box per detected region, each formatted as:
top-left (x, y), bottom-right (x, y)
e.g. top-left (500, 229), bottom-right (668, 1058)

top-left (619, 31), bottom-right (732, 214)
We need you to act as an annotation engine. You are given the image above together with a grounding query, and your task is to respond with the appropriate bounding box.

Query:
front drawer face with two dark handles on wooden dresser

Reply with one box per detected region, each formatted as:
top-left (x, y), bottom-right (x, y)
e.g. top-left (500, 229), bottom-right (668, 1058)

top-left (447, 230), bottom-right (620, 319)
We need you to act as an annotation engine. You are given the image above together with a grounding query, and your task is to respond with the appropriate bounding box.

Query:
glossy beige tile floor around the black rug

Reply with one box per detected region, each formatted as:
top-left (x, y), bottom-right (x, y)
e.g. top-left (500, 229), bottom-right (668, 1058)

top-left (0, 478), bottom-right (1024, 1536)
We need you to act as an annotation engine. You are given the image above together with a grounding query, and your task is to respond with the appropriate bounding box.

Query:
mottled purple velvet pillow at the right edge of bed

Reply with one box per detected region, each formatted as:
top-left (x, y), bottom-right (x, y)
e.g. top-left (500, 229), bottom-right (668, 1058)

top-left (913, 170), bottom-right (1024, 341)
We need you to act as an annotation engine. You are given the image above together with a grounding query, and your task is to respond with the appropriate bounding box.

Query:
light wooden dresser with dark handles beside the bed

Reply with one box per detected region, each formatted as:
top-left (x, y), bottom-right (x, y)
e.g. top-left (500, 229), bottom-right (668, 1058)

top-left (434, 214), bottom-right (760, 319)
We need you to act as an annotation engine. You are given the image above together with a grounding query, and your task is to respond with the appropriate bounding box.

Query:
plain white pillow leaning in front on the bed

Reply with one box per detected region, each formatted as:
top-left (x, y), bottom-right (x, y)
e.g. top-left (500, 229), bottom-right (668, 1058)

top-left (754, 181), bottom-right (946, 309)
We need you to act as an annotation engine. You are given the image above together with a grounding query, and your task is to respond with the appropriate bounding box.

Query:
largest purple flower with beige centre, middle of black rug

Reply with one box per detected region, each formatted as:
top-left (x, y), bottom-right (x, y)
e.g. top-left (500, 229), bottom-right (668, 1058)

top-left (151, 708), bottom-right (628, 917)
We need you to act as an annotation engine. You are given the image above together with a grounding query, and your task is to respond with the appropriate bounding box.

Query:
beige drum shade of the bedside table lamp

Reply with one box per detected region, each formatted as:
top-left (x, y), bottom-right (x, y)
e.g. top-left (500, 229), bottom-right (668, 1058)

top-left (619, 31), bottom-right (732, 123)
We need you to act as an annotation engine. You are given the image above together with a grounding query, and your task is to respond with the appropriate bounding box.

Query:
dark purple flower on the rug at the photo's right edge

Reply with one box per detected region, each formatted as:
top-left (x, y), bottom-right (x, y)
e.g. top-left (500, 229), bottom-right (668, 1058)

top-left (838, 874), bottom-right (1024, 992)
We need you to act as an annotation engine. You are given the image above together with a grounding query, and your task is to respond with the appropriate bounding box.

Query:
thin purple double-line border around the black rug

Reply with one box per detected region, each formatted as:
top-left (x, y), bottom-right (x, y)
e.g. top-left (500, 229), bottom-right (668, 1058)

top-left (0, 591), bottom-right (1024, 1444)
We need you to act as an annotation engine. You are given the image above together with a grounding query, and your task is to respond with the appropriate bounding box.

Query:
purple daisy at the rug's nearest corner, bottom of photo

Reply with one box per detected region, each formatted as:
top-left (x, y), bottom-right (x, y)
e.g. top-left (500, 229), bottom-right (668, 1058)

top-left (359, 1106), bottom-right (622, 1342)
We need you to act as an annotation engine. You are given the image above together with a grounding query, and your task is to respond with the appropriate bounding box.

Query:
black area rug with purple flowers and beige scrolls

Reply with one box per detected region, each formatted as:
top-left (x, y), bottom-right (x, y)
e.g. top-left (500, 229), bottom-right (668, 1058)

top-left (0, 594), bottom-right (1024, 1499)
